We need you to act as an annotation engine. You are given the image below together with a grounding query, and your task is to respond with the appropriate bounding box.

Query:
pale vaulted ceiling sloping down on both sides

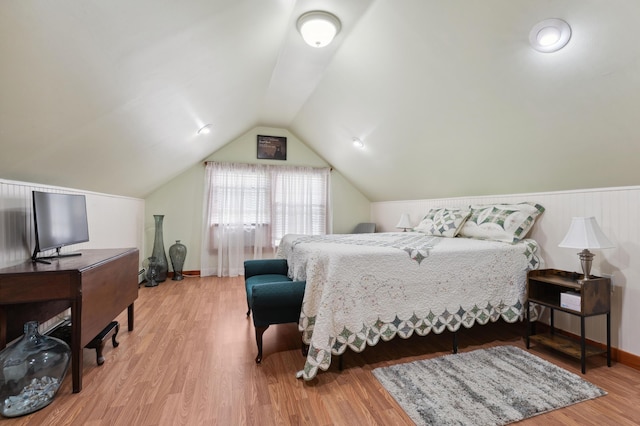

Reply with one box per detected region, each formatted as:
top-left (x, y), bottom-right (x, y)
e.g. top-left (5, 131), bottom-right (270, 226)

top-left (0, 0), bottom-right (640, 201)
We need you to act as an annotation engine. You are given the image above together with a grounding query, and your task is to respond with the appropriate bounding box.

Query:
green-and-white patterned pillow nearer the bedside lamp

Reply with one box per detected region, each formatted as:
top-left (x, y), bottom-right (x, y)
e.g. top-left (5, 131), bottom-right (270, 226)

top-left (460, 203), bottom-right (544, 243)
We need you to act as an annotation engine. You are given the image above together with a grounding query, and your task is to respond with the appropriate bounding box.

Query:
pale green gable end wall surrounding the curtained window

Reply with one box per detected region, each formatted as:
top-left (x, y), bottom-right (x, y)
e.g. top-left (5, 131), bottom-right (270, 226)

top-left (144, 127), bottom-right (370, 271)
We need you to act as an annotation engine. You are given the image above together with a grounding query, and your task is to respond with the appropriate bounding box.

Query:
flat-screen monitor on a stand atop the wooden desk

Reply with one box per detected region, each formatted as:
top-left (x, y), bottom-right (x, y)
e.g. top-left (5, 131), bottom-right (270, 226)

top-left (31, 191), bottom-right (89, 263)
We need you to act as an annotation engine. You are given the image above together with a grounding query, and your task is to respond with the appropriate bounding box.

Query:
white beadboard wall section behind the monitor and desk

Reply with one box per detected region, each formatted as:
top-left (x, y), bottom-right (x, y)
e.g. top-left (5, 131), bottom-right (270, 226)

top-left (0, 180), bottom-right (144, 267)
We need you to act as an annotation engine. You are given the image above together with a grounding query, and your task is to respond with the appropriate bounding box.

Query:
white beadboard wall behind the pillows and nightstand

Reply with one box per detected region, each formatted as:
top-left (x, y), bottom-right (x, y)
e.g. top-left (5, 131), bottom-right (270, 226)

top-left (371, 187), bottom-right (640, 355)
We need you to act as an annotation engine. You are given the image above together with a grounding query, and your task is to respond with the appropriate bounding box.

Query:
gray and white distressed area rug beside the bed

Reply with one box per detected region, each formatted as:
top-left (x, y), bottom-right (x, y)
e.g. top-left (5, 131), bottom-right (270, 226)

top-left (373, 346), bottom-right (607, 426)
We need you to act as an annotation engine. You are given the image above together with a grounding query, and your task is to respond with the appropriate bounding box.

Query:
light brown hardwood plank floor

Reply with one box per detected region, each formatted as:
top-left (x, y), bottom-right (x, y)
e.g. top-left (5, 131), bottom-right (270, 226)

top-left (5, 277), bottom-right (640, 426)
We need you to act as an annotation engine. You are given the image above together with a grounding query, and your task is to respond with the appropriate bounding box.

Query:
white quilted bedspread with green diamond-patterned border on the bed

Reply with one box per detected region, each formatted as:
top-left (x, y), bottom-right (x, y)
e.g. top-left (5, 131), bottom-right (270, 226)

top-left (278, 232), bottom-right (540, 380)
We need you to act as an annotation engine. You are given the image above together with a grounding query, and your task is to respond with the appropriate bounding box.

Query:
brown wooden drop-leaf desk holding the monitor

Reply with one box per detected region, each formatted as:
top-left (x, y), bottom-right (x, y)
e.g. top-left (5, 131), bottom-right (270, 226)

top-left (0, 248), bottom-right (139, 393)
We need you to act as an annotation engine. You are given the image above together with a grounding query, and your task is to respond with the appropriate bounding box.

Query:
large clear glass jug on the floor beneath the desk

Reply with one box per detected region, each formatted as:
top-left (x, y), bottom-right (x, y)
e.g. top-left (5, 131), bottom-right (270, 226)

top-left (0, 321), bottom-right (71, 417)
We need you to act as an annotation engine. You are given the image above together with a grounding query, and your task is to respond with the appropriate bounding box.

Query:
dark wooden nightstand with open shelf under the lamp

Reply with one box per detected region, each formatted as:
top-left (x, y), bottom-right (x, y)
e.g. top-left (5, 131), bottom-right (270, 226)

top-left (525, 269), bottom-right (611, 374)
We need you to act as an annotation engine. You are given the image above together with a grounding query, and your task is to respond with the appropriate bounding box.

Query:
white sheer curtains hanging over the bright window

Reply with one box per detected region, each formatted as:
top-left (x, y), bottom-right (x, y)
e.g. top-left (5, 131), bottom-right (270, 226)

top-left (200, 162), bottom-right (331, 276)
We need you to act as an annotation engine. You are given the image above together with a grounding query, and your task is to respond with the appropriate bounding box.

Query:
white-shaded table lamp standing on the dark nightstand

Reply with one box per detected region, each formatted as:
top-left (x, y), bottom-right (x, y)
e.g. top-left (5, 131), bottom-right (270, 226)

top-left (558, 217), bottom-right (614, 280)
